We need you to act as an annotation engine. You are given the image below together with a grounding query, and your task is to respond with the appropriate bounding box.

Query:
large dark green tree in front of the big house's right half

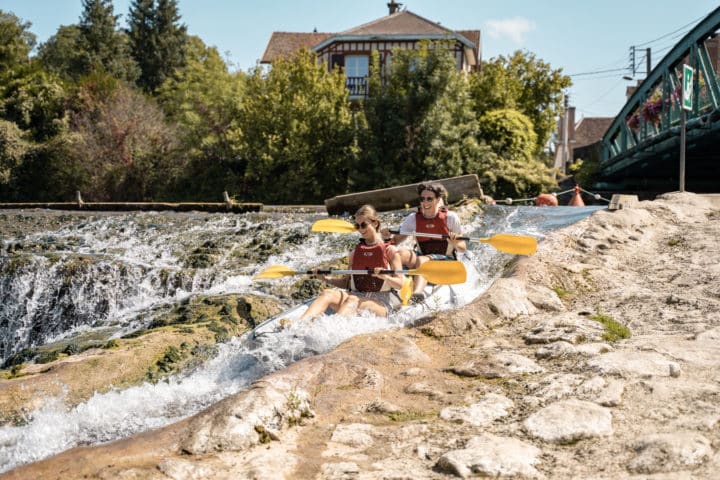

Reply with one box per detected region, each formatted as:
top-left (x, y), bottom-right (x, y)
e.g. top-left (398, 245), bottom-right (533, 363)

top-left (362, 42), bottom-right (479, 188)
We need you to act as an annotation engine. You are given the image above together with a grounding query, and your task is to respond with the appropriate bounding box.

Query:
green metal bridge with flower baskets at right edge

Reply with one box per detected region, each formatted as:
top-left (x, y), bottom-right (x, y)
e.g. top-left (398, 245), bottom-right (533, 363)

top-left (593, 7), bottom-right (720, 193)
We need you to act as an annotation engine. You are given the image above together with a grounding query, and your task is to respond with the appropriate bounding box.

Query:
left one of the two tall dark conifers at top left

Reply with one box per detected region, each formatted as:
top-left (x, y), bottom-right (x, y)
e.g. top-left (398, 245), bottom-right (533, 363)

top-left (73, 0), bottom-right (138, 81)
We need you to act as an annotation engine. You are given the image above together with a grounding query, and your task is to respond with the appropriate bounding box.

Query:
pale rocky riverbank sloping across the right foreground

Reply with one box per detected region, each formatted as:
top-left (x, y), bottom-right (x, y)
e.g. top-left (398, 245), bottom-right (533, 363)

top-left (0, 193), bottom-right (720, 479)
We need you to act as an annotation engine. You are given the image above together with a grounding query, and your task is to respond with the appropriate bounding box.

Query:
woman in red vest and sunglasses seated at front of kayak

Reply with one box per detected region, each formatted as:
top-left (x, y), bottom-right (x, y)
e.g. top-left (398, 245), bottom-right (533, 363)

top-left (301, 205), bottom-right (404, 318)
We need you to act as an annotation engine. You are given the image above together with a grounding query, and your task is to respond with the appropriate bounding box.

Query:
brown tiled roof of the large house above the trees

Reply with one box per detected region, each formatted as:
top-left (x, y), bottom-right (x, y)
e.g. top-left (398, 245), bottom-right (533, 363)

top-left (260, 10), bottom-right (480, 63)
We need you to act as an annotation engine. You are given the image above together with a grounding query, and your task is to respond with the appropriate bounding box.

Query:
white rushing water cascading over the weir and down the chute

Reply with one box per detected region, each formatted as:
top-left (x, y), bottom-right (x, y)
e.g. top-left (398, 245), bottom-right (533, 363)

top-left (0, 206), bottom-right (600, 472)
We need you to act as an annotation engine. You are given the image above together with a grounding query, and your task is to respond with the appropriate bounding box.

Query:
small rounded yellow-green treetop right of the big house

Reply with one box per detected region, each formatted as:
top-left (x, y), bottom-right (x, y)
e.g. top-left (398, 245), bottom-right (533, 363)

top-left (480, 109), bottom-right (537, 160)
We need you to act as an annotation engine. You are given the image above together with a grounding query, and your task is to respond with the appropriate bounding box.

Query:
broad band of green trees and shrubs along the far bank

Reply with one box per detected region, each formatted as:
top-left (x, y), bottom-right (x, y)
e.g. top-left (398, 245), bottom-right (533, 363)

top-left (0, 6), bottom-right (569, 204)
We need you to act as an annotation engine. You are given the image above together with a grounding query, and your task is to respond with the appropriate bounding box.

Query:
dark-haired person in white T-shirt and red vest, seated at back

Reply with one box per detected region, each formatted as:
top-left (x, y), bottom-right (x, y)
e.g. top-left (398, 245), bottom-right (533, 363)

top-left (382, 183), bottom-right (467, 303)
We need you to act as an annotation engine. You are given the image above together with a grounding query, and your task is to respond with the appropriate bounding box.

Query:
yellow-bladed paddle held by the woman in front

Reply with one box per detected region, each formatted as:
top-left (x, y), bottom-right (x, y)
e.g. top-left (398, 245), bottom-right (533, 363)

top-left (253, 260), bottom-right (467, 285)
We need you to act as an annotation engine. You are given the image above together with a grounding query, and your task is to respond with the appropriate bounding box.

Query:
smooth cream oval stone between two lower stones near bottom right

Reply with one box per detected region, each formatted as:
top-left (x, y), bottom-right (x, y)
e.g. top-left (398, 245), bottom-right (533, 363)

top-left (523, 399), bottom-right (613, 444)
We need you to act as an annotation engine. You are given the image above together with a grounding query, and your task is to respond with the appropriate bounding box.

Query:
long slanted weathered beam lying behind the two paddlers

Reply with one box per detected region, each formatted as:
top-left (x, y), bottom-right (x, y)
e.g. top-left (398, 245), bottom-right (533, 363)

top-left (325, 174), bottom-right (483, 215)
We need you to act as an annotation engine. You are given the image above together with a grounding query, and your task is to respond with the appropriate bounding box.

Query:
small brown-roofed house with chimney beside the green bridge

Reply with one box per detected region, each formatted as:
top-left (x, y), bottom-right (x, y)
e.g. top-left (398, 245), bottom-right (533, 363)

top-left (554, 105), bottom-right (615, 173)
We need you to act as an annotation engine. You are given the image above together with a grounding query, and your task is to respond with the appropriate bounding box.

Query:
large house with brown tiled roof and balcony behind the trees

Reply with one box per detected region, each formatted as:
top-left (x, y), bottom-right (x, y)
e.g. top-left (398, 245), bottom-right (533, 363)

top-left (260, 0), bottom-right (481, 99)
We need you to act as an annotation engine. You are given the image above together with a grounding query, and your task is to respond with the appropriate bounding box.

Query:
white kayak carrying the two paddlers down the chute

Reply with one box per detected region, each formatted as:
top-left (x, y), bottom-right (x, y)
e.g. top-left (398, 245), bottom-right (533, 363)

top-left (250, 252), bottom-right (483, 339)
